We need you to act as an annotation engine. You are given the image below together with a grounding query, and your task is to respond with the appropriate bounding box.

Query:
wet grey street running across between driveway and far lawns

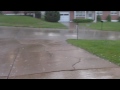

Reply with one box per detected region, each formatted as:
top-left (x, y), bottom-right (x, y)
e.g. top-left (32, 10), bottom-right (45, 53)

top-left (0, 28), bottom-right (120, 40)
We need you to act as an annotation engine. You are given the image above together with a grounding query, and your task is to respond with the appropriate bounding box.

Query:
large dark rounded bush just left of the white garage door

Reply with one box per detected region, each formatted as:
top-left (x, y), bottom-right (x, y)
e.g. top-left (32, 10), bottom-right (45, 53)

top-left (45, 11), bottom-right (60, 22)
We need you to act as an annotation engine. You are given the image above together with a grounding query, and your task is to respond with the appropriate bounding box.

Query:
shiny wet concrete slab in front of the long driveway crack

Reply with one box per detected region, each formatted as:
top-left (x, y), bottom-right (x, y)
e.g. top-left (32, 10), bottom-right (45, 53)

top-left (10, 68), bottom-right (120, 79)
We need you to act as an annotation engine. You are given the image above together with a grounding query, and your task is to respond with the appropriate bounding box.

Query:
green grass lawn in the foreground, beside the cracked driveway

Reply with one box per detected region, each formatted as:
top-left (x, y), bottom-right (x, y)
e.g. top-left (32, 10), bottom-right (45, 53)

top-left (67, 39), bottom-right (120, 66)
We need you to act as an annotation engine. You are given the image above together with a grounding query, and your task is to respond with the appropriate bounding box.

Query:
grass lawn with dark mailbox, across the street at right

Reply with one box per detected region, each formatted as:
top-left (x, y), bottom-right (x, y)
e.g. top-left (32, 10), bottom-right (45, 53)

top-left (79, 22), bottom-right (120, 31)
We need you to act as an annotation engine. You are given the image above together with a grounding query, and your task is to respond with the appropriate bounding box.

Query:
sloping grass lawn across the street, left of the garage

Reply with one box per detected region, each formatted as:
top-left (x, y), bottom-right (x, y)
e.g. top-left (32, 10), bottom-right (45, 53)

top-left (0, 15), bottom-right (67, 29)
